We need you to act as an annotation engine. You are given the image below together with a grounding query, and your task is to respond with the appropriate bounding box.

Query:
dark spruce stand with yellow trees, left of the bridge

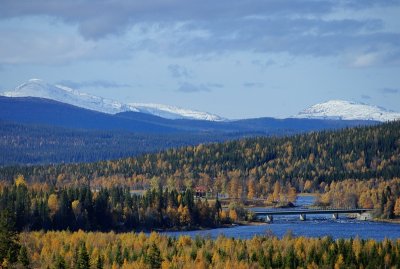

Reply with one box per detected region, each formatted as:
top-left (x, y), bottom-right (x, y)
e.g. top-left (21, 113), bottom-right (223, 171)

top-left (0, 178), bottom-right (231, 231)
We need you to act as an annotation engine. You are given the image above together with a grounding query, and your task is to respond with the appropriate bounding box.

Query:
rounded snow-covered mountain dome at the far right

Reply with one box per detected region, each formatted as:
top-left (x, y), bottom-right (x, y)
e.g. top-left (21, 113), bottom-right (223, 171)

top-left (294, 100), bottom-right (400, 122)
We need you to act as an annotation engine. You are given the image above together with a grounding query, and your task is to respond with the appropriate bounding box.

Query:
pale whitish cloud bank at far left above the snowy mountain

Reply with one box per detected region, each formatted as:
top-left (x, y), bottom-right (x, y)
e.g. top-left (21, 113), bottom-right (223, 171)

top-left (0, 18), bottom-right (137, 65)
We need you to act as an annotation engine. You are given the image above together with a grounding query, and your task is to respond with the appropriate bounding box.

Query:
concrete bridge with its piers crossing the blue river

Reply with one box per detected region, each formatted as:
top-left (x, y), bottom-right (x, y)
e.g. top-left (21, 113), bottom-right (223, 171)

top-left (250, 208), bottom-right (372, 222)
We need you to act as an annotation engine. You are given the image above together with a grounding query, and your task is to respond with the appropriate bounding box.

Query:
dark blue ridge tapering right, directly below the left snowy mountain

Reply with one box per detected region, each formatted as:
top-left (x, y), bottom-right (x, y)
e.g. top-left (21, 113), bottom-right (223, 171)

top-left (0, 96), bottom-right (181, 134)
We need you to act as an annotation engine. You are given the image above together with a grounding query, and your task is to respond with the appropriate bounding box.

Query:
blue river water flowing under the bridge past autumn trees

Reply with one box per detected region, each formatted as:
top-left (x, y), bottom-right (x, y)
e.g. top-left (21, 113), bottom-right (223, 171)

top-left (164, 196), bottom-right (400, 240)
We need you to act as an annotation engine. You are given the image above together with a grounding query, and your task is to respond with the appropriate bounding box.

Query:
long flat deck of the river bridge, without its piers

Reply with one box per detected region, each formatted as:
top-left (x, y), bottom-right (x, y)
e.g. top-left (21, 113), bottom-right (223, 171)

top-left (252, 208), bottom-right (372, 216)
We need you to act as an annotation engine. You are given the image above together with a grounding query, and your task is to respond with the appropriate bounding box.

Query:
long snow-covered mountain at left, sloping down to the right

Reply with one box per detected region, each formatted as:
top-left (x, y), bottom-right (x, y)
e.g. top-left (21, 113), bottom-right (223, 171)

top-left (2, 79), bottom-right (223, 121)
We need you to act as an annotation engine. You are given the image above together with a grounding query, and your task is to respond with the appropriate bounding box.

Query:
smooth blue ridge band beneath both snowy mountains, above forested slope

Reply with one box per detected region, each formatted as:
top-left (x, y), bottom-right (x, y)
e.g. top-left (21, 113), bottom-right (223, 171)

top-left (0, 96), bottom-right (374, 136)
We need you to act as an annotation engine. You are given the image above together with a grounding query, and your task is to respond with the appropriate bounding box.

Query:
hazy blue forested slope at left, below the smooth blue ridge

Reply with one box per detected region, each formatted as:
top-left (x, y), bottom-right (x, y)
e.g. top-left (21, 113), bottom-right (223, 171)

top-left (0, 120), bottom-right (241, 166)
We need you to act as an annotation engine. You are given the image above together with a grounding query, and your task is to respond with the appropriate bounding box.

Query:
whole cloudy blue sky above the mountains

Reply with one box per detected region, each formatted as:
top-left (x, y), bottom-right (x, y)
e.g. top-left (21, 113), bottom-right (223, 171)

top-left (0, 0), bottom-right (400, 118)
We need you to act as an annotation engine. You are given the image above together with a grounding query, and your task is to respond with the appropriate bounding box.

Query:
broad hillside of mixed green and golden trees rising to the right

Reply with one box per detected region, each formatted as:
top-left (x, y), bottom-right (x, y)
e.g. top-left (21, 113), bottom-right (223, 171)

top-left (0, 121), bottom-right (400, 198)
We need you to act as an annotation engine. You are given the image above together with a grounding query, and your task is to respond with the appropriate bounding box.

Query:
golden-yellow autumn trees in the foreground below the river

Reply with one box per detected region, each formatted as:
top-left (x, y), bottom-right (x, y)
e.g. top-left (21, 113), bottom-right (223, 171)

top-left (10, 231), bottom-right (400, 269)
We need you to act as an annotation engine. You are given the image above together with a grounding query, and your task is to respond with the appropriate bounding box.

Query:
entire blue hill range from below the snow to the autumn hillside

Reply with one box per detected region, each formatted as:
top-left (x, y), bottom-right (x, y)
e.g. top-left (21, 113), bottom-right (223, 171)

top-left (0, 96), bottom-right (376, 166)
